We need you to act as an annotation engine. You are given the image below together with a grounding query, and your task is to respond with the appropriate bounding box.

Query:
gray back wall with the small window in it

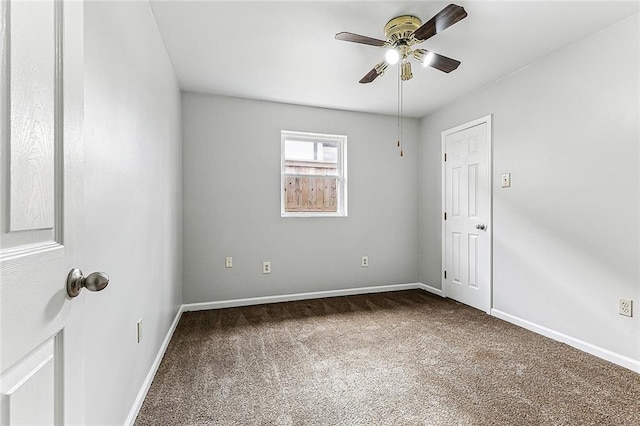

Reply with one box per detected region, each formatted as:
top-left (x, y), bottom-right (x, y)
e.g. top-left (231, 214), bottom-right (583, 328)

top-left (182, 93), bottom-right (418, 303)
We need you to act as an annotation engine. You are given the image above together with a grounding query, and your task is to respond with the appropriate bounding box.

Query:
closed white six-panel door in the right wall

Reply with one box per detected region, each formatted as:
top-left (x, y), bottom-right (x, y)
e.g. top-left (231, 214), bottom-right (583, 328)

top-left (442, 116), bottom-right (492, 313)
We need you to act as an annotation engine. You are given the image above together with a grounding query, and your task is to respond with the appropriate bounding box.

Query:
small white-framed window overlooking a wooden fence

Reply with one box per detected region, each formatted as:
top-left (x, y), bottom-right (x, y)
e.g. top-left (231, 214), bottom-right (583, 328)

top-left (281, 130), bottom-right (347, 217)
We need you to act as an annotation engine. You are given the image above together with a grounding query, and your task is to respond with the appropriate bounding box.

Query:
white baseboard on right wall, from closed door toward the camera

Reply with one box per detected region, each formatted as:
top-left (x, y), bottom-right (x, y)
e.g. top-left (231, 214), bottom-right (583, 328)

top-left (491, 309), bottom-right (640, 373)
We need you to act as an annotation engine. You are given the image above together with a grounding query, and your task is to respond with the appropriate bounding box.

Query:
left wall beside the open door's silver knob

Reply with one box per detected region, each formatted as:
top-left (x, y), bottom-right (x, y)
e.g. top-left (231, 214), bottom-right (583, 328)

top-left (80, 1), bottom-right (182, 424)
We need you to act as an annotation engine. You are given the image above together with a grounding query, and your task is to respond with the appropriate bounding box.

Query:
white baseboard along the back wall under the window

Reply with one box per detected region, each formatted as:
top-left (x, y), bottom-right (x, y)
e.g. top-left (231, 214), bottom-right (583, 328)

top-left (182, 283), bottom-right (428, 312)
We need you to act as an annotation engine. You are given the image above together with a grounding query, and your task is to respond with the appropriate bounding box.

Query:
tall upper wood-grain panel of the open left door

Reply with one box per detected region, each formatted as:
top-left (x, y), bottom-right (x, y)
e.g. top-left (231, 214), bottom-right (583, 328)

top-left (9, 1), bottom-right (56, 231)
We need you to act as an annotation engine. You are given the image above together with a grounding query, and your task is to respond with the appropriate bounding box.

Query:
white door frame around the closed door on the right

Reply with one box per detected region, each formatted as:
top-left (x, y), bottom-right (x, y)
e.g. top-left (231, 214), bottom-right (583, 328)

top-left (440, 114), bottom-right (493, 315)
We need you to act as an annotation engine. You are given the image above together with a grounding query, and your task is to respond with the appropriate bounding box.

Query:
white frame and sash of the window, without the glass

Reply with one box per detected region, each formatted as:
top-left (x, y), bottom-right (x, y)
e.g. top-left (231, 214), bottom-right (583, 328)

top-left (280, 130), bottom-right (348, 217)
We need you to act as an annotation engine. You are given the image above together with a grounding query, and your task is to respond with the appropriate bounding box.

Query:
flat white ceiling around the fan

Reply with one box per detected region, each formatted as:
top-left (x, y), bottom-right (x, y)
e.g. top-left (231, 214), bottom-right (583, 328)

top-left (151, 0), bottom-right (640, 117)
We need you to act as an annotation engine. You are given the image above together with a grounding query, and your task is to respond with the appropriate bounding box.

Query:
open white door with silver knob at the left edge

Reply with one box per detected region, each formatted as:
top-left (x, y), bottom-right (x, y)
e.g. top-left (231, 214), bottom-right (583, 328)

top-left (0, 0), bottom-right (84, 425)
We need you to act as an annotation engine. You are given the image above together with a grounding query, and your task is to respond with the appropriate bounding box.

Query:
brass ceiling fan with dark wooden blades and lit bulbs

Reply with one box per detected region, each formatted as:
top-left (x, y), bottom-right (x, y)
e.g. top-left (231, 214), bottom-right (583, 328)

top-left (336, 4), bottom-right (467, 83)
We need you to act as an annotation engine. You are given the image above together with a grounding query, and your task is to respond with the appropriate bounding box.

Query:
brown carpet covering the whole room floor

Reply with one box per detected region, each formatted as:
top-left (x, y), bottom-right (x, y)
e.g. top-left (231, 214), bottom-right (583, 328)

top-left (136, 290), bottom-right (640, 425)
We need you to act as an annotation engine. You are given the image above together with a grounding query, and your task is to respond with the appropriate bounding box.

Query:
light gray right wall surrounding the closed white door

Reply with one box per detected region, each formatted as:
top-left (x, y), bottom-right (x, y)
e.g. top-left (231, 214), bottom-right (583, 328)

top-left (419, 15), bottom-right (640, 360)
